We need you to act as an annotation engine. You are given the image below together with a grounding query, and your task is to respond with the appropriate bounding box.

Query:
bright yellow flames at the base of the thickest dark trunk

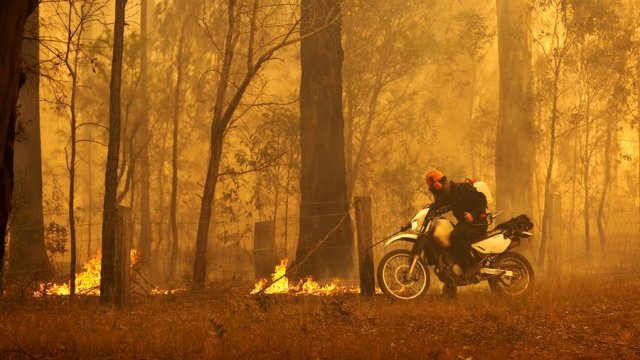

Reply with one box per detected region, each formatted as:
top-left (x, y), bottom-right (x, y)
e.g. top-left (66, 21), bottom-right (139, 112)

top-left (251, 257), bottom-right (360, 295)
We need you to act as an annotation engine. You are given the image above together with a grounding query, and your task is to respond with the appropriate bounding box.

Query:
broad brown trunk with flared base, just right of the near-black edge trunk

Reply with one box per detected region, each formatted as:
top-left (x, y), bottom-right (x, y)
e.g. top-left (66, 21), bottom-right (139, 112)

top-left (8, 10), bottom-right (53, 281)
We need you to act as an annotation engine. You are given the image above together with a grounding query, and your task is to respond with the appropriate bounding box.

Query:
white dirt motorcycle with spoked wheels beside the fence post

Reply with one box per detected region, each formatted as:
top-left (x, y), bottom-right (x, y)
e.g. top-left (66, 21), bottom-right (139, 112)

top-left (377, 205), bottom-right (534, 300)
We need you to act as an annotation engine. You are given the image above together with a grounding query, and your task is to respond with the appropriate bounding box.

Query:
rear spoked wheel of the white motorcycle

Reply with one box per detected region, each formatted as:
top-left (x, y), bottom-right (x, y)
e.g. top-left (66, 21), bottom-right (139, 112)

top-left (489, 252), bottom-right (534, 298)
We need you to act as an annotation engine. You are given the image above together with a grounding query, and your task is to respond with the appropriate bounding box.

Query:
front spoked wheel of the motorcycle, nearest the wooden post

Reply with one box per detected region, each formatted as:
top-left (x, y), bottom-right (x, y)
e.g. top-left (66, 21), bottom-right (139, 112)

top-left (378, 249), bottom-right (429, 300)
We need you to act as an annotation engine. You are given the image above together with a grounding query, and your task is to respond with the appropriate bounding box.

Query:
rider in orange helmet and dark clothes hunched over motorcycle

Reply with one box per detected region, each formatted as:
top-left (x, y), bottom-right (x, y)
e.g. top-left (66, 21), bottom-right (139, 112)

top-left (425, 170), bottom-right (487, 272)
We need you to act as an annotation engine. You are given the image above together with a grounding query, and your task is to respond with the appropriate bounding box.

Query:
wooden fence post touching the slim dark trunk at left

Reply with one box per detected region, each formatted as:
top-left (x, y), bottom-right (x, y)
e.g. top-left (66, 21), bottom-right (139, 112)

top-left (114, 206), bottom-right (133, 307)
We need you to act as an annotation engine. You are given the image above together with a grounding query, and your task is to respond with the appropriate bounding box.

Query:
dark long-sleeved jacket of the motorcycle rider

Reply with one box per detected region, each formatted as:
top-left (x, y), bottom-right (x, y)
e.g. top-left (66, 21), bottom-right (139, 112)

top-left (432, 181), bottom-right (487, 224)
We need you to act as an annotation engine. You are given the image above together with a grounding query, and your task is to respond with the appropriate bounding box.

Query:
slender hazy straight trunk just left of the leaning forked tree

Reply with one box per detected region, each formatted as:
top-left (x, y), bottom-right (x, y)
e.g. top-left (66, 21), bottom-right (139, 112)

top-left (168, 21), bottom-right (187, 280)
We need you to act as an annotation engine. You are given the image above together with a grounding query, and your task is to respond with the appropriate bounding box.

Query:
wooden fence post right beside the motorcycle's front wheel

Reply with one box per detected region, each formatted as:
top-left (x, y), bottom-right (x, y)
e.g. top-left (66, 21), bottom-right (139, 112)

top-left (355, 196), bottom-right (376, 296)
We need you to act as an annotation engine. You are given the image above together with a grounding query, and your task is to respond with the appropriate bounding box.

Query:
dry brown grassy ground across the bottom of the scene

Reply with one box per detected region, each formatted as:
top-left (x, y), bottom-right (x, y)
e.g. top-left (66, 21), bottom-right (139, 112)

top-left (0, 274), bottom-right (640, 359)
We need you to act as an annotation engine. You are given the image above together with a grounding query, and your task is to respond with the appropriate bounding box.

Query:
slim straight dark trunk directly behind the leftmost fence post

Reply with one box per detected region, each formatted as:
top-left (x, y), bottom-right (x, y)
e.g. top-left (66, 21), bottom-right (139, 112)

top-left (100, 0), bottom-right (126, 303)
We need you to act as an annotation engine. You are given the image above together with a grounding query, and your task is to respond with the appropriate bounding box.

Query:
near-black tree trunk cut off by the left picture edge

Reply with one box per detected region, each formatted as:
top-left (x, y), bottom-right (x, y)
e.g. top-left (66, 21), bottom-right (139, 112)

top-left (0, 0), bottom-right (38, 293)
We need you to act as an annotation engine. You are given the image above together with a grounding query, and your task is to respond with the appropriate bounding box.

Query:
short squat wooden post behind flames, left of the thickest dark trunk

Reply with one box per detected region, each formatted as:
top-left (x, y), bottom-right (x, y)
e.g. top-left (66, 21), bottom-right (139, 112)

top-left (253, 221), bottom-right (278, 279)
